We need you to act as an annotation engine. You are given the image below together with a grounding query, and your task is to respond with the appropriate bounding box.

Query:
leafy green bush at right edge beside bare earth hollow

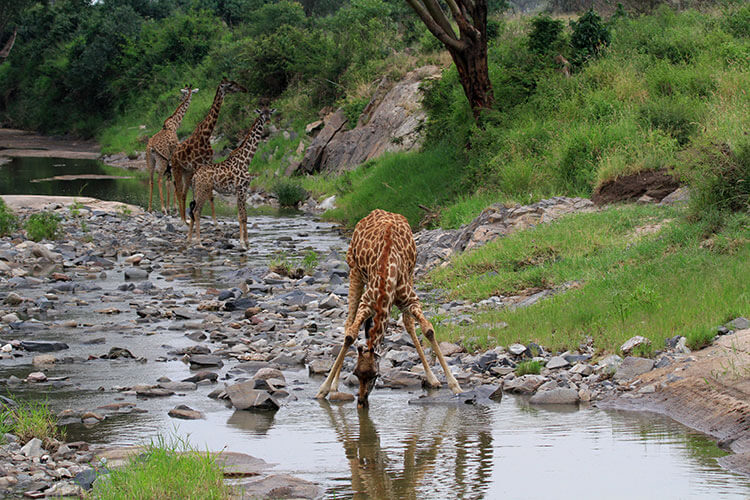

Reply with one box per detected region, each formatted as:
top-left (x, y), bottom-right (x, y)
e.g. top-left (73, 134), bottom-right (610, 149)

top-left (682, 142), bottom-right (750, 225)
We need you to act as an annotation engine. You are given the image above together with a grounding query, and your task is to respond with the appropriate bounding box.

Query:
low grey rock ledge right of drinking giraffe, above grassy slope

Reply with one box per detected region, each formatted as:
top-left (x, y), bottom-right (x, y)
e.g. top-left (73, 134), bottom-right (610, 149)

top-left (415, 196), bottom-right (594, 274)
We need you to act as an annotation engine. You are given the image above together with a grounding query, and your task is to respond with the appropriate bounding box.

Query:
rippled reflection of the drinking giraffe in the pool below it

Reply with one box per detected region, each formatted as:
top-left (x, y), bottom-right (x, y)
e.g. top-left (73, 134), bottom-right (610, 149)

top-left (320, 401), bottom-right (493, 499)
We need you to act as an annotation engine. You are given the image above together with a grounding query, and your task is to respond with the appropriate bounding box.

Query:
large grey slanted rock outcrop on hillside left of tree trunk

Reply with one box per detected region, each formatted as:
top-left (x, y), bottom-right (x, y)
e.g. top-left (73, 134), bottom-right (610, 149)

top-left (298, 66), bottom-right (440, 173)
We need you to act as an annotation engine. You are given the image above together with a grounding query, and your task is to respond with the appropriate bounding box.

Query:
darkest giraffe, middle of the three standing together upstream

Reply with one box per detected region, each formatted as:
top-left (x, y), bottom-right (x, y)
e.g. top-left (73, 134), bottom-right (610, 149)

top-left (169, 77), bottom-right (247, 224)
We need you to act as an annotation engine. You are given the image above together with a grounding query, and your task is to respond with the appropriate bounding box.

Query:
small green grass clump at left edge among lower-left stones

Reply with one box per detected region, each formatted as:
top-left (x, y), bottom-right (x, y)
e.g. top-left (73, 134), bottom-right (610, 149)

top-left (0, 401), bottom-right (65, 445)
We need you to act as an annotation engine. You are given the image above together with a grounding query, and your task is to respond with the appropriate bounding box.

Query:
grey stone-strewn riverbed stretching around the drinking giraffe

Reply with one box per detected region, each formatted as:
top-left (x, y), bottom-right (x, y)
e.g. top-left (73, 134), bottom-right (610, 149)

top-left (0, 199), bottom-right (744, 497)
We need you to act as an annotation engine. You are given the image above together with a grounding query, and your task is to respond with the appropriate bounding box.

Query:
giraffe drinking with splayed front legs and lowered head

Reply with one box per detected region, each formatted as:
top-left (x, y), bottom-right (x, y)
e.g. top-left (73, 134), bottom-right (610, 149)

top-left (315, 210), bottom-right (461, 408)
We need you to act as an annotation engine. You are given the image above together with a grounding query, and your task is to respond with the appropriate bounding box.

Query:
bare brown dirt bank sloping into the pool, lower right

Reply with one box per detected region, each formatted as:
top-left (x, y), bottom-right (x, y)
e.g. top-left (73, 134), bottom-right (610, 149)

top-left (599, 329), bottom-right (750, 475)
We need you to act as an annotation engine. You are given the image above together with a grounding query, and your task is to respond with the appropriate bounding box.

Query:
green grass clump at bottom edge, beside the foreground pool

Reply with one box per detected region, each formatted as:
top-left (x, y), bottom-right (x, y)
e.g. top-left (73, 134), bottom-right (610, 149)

top-left (93, 436), bottom-right (230, 500)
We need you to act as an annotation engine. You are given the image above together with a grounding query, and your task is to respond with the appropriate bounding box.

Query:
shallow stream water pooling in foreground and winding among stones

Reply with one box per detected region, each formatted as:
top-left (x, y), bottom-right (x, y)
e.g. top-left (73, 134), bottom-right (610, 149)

top-left (0, 155), bottom-right (750, 499)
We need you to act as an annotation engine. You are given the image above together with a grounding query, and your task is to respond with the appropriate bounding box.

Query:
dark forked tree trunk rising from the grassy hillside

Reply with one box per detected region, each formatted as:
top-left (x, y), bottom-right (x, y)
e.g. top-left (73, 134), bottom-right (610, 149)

top-left (406, 0), bottom-right (495, 120)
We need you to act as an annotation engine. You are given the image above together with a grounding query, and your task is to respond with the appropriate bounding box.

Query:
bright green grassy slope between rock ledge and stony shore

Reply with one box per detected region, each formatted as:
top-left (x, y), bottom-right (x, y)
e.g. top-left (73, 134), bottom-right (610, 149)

top-left (429, 206), bottom-right (750, 352)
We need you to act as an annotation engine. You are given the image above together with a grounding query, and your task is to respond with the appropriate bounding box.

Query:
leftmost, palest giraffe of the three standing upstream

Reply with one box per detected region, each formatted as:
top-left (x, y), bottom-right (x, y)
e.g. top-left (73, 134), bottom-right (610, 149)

top-left (146, 84), bottom-right (198, 213)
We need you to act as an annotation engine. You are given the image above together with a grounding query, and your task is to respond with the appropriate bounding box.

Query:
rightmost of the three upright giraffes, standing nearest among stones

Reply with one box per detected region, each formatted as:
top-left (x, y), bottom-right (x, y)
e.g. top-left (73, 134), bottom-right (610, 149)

top-left (188, 108), bottom-right (276, 249)
